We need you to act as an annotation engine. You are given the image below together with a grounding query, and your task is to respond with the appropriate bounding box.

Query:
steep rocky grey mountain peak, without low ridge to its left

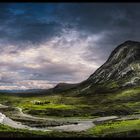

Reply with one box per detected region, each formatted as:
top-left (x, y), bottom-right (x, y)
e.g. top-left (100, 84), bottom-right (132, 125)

top-left (80, 40), bottom-right (140, 93)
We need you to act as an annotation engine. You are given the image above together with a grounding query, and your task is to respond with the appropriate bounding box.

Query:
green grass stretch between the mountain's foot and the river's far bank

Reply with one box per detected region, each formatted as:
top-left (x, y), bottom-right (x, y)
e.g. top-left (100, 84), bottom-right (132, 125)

top-left (0, 87), bottom-right (140, 118)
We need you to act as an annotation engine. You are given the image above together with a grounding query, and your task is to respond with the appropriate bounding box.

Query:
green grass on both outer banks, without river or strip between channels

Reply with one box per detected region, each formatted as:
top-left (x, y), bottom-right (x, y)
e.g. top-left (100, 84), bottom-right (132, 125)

top-left (0, 84), bottom-right (140, 137)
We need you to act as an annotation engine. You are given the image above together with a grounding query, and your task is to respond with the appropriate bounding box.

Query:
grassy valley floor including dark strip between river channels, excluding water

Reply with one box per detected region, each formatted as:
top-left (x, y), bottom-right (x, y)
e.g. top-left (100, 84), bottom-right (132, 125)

top-left (0, 87), bottom-right (140, 137)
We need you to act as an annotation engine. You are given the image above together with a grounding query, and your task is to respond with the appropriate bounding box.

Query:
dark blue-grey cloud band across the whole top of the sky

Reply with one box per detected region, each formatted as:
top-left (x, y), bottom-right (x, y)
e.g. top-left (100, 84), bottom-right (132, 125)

top-left (0, 3), bottom-right (140, 46)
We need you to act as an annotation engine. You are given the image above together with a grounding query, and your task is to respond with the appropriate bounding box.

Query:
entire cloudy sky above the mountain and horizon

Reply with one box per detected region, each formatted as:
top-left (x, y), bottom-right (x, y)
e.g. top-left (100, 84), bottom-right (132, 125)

top-left (0, 3), bottom-right (140, 89)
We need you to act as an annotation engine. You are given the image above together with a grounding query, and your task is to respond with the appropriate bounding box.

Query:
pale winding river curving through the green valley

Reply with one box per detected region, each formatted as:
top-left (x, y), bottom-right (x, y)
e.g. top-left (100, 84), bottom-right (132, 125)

top-left (0, 104), bottom-right (128, 132)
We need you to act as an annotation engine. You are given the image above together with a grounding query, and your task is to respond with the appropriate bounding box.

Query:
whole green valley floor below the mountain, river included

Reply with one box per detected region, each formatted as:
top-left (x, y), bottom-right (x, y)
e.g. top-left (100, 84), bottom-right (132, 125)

top-left (0, 87), bottom-right (140, 137)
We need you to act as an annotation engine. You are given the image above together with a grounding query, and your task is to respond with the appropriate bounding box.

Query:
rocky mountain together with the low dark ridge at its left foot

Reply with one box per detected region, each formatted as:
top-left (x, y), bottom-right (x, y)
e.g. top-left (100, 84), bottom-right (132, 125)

top-left (46, 40), bottom-right (140, 94)
